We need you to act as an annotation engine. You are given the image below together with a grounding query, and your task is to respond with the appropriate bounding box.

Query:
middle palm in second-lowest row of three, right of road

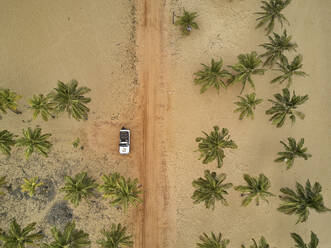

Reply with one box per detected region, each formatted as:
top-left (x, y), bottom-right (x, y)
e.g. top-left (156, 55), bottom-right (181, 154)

top-left (234, 174), bottom-right (274, 207)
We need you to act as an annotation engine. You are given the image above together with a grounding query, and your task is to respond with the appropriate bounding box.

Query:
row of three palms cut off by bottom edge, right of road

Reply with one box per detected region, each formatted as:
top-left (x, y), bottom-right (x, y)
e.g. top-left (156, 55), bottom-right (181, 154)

top-left (197, 232), bottom-right (319, 248)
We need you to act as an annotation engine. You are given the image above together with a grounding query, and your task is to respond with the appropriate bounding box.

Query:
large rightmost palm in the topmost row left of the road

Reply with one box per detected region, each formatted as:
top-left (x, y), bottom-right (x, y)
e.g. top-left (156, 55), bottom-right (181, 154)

top-left (51, 79), bottom-right (91, 121)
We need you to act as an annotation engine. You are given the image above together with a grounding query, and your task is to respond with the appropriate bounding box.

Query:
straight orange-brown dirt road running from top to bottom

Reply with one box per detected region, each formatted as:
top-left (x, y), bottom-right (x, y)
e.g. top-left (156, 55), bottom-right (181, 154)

top-left (137, 0), bottom-right (167, 248)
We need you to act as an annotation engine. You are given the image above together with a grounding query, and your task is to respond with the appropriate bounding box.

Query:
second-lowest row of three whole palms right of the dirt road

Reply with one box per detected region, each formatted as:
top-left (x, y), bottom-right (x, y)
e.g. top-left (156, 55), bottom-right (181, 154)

top-left (192, 170), bottom-right (331, 223)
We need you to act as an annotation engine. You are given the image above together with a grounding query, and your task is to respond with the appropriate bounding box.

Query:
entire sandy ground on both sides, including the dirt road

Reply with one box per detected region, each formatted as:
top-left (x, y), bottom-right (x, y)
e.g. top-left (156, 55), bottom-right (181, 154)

top-left (0, 0), bottom-right (331, 248)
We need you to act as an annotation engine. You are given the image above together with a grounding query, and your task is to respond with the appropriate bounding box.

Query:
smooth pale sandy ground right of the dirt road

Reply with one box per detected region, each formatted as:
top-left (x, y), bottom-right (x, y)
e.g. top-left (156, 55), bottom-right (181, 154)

top-left (164, 0), bottom-right (331, 248)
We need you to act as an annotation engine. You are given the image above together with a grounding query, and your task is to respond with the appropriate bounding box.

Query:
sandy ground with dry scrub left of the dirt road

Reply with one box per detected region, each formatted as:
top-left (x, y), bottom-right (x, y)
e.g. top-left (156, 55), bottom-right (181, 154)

top-left (0, 0), bottom-right (142, 246)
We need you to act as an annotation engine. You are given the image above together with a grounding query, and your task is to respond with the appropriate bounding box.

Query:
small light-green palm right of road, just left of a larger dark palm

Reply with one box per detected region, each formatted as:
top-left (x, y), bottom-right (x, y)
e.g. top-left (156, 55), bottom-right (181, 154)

top-left (233, 92), bottom-right (263, 120)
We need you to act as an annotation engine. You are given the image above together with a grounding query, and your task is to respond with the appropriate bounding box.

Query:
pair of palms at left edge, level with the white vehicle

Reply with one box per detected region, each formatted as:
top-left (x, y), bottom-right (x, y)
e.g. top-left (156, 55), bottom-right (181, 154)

top-left (0, 127), bottom-right (52, 158)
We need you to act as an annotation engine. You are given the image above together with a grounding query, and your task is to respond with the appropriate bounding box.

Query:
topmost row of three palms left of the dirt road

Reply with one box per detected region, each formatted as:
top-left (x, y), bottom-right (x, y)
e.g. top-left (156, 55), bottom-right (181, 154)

top-left (0, 79), bottom-right (91, 121)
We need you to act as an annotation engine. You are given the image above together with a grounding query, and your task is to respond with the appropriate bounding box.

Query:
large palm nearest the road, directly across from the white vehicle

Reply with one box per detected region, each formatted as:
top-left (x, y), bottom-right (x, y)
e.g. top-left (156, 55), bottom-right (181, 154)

top-left (195, 126), bottom-right (238, 168)
